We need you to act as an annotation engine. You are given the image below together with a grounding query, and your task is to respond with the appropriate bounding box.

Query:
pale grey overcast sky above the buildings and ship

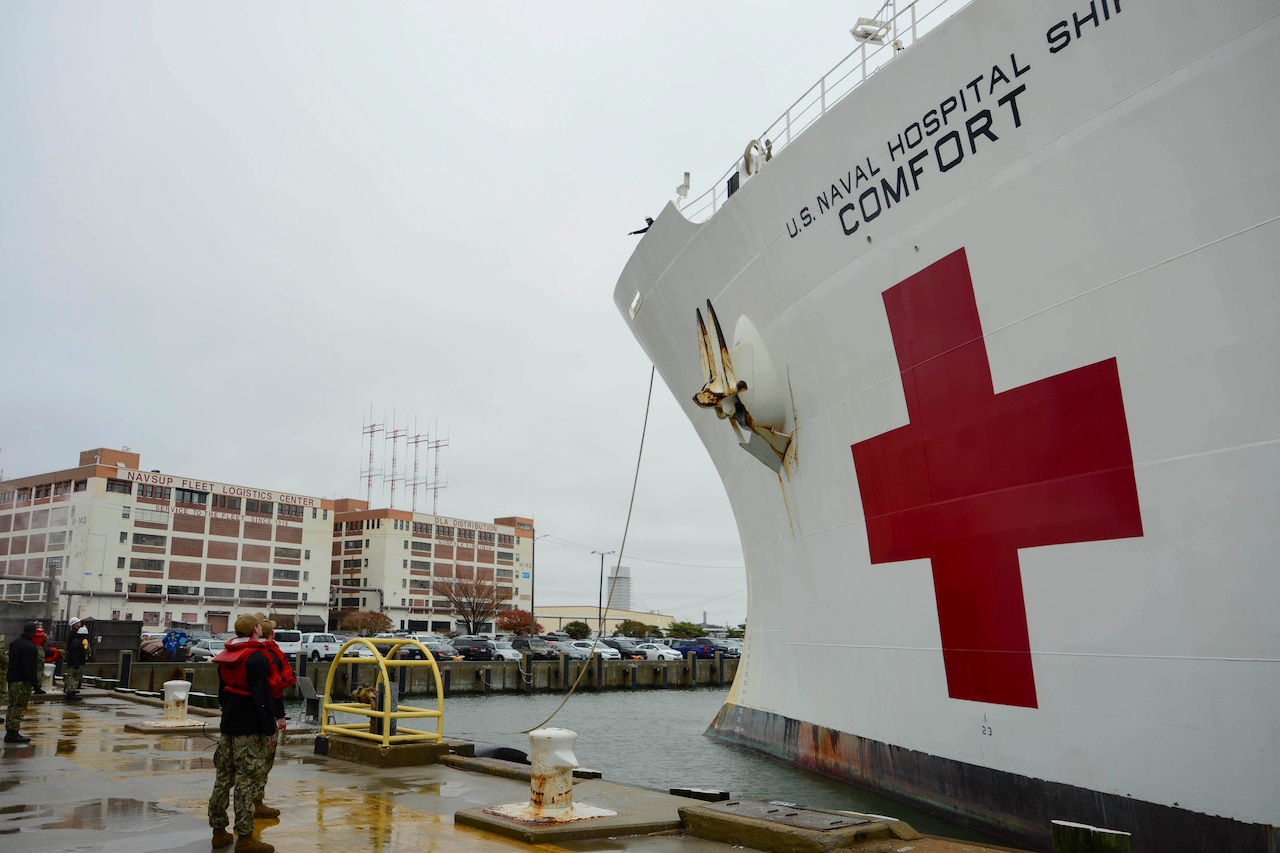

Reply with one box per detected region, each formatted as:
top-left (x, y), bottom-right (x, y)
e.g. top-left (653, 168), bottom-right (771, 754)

top-left (0, 0), bottom-right (878, 624)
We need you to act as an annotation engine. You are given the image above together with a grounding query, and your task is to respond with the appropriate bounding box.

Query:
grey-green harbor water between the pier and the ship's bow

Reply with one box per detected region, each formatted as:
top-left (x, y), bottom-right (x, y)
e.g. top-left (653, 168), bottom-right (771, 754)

top-left (414, 688), bottom-right (1001, 844)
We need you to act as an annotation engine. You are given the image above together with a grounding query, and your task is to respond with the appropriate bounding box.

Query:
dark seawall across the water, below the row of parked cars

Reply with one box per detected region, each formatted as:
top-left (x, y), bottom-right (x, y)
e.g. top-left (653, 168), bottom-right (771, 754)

top-left (84, 654), bottom-right (739, 698)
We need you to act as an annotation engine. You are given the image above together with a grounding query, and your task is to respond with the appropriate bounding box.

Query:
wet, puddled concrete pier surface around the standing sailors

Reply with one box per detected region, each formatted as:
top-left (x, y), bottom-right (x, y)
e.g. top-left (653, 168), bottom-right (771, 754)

top-left (0, 689), bottom-right (1024, 853)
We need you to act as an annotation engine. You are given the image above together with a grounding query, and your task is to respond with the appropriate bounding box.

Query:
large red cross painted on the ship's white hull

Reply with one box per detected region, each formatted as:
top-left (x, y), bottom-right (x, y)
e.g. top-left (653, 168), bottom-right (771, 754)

top-left (852, 248), bottom-right (1142, 707)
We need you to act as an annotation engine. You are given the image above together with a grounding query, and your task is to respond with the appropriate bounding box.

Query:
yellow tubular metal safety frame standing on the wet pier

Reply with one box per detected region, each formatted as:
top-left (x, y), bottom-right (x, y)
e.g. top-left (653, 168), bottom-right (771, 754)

top-left (320, 637), bottom-right (444, 747)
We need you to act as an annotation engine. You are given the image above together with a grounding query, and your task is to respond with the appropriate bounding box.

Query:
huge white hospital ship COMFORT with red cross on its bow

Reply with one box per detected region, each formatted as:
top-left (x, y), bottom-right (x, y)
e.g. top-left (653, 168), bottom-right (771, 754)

top-left (614, 0), bottom-right (1280, 853)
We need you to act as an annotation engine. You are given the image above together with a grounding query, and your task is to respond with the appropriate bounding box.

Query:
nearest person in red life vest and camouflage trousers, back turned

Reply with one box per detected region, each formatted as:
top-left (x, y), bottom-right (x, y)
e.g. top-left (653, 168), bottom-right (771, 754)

top-left (209, 613), bottom-right (279, 853)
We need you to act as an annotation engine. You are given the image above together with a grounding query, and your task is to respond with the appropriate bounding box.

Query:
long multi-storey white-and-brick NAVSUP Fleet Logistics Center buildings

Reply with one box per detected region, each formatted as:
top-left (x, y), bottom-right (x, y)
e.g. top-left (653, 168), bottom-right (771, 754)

top-left (0, 448), bottom-right (532, 631)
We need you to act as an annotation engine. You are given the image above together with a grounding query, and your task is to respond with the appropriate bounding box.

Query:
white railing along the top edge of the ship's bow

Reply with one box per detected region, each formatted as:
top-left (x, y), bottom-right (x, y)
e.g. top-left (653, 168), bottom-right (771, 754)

top-left (678, 0), bottom-right (972, 222)
